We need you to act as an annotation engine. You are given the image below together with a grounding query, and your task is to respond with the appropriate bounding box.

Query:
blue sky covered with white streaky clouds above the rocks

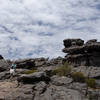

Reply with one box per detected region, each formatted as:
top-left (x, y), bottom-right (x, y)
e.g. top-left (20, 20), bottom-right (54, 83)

top-left (0, 0), bottom-right (100, 59)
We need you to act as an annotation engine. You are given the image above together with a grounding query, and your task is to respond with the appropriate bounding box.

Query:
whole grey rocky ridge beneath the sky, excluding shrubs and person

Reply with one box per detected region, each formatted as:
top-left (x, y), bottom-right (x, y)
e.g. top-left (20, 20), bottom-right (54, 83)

top-left (0, 39), bottom-right (100, 100)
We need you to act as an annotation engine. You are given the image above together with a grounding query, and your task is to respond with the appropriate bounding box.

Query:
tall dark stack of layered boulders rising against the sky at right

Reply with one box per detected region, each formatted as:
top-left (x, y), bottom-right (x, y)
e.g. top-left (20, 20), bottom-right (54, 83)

top-left (63, 39), bottom-right (100, 66)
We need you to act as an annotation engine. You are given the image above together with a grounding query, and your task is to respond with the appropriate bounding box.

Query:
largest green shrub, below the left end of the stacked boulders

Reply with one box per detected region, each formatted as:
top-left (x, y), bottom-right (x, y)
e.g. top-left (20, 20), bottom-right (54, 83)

top-left (52, 62), bottom-right (72, 76)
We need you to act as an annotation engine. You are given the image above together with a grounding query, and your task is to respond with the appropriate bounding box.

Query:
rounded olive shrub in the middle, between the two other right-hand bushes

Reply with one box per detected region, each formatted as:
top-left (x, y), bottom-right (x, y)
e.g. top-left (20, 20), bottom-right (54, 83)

top-left (71, 72), bottom-right (85, 82)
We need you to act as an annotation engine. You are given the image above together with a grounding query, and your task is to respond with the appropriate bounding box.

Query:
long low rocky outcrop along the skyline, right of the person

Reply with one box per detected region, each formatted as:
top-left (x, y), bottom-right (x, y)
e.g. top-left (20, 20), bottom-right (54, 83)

top-left (15, 57), bottom-right (63, 69)
